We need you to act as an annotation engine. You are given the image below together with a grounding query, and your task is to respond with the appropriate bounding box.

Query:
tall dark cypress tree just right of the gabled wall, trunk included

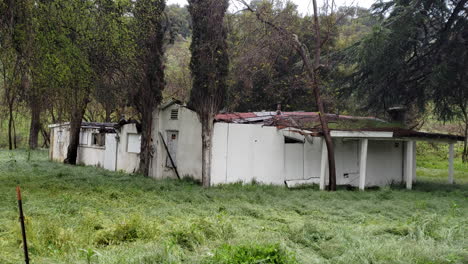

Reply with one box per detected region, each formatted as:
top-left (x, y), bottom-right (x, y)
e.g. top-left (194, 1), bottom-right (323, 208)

top-left (189, 0), bottom-right (229, 187)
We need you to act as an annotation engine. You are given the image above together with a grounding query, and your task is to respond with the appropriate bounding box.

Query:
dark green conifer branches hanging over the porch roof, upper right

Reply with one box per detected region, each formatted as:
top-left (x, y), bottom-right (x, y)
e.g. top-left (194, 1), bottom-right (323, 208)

top-left (347, 0), bottom-right (468, 123)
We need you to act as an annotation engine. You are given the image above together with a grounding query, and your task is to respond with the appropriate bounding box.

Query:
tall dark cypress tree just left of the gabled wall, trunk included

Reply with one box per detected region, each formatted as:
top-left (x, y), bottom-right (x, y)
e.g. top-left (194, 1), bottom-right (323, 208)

top-left (131, 0), bottom-right (166, 176)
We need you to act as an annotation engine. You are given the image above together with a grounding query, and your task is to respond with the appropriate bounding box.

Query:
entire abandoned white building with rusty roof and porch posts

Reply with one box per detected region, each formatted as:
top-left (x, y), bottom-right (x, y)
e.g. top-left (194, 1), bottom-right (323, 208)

top-left (50, 101), bottom-right (464, 189)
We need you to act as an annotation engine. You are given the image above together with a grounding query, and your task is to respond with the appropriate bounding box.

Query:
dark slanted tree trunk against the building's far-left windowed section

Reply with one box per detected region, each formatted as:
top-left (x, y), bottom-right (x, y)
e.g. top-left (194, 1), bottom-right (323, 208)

top-left (63, 104), bottom-right (87, 165)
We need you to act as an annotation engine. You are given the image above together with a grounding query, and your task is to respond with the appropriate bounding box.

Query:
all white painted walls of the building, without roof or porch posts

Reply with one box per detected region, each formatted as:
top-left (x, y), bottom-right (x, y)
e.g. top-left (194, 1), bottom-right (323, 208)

top-left (50, 104), bottom-right (410, 186)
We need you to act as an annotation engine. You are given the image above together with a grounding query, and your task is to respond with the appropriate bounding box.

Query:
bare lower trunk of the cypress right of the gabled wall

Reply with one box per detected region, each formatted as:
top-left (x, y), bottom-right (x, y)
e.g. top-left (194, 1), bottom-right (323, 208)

top-left (201, 116), bottom-right (213, 187)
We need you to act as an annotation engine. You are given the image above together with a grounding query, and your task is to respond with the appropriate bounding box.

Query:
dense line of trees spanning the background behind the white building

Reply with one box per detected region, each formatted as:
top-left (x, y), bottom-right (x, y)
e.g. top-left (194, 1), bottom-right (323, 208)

top-left (0, 0), bottom-right (468, 174)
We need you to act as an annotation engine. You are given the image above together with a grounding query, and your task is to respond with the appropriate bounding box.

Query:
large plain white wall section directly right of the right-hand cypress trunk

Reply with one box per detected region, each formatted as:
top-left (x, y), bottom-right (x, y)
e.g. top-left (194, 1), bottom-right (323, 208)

top-left (211, 123), bottom-right (284, 185)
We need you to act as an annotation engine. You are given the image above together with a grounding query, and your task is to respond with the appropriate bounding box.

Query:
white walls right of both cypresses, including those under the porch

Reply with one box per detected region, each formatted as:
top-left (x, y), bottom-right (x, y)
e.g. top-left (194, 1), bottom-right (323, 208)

top-left (211, 123), bottom-right (403, 186)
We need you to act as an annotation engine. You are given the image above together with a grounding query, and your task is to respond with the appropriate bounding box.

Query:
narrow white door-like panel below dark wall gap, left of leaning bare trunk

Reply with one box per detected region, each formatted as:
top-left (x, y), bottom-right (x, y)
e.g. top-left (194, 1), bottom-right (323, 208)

top-left (284, 143), bottom-right (304, 180)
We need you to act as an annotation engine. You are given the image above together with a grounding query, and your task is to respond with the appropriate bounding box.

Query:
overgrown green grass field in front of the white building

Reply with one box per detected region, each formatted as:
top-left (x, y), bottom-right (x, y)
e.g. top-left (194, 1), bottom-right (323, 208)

top-left (0, 150), bottom-right (468, 264)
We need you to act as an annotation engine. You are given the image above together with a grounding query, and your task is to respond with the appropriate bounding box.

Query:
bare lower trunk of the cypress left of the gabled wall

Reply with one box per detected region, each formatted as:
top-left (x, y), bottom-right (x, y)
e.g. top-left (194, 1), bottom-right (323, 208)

top-left (139, 109), bottom-right (153, 176)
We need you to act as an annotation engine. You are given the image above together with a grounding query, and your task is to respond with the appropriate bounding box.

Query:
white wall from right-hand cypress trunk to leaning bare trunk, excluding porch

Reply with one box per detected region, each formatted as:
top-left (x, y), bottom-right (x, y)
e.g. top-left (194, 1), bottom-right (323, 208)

top-left (211, 123), bottom-right (321, 185)
